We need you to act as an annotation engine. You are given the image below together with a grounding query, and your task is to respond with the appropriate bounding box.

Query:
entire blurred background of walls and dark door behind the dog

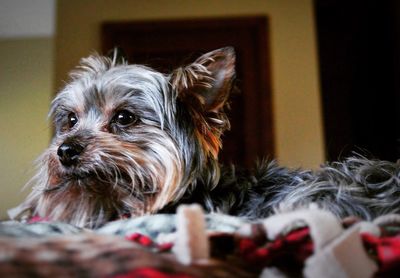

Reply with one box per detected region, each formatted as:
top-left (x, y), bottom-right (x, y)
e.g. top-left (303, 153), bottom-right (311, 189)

top-left (0, 0), bottom-right (400, 218)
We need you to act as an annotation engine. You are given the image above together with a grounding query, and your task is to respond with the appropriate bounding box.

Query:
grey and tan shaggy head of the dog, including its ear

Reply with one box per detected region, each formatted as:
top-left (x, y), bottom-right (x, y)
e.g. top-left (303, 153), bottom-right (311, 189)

top-left (18, 48), bottom-right (235, 227)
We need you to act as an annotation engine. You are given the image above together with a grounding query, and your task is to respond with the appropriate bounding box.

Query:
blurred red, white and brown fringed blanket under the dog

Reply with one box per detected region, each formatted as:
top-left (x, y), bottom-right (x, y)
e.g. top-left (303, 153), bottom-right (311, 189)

top-left (0, 205), bottom-right (400, 278)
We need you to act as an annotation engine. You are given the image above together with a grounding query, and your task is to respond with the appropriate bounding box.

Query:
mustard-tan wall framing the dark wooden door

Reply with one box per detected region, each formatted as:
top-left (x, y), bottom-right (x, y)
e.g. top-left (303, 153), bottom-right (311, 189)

top-left (55, 0), bottom-right (324, 167)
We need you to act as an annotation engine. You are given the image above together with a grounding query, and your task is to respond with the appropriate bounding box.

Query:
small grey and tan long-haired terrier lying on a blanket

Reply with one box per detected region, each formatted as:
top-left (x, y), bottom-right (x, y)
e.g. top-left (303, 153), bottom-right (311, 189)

top-left (10, 47), bottom-right (400, 228)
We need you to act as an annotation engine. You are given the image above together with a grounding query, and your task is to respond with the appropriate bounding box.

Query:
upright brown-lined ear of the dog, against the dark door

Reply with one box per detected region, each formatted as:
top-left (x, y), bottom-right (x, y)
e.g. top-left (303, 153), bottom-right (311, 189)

top-left (171, 47), bottom-right (235, 159)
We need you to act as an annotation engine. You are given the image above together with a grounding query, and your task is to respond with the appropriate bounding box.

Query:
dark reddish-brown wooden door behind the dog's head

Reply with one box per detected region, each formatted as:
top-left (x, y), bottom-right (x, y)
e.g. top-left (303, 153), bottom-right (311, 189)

top-left (102, 17), bottom-right (274, 167)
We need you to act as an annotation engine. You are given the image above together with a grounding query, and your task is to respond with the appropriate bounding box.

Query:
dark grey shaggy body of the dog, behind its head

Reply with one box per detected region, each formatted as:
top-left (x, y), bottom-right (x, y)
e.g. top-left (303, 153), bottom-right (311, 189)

top-left (167, 156), bottom-right (400, 220)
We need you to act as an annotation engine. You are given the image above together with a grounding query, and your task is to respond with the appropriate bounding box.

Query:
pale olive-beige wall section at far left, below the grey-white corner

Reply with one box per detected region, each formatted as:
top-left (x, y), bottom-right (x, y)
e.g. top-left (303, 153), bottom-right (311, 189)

top-left (0, 38), bottom-right (53, 218)
